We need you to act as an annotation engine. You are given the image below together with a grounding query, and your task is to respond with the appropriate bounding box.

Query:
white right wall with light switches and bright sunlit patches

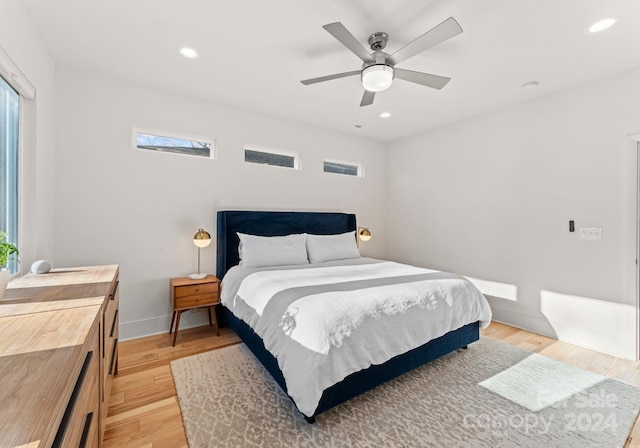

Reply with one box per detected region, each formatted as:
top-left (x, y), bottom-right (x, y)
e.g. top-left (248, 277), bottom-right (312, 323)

top-left (387, 70), bottom-right (640, 358)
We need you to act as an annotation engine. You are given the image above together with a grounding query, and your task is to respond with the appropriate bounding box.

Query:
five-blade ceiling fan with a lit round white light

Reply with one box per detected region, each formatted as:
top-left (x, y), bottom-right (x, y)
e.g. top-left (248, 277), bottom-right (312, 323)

top-left (300, 17), bottom-right (462, 107)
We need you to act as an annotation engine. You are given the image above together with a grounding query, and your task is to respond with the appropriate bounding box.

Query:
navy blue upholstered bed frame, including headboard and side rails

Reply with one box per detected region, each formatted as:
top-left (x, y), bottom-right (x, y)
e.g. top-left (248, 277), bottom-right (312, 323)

top-left (216, 211), bottom-right (480, 423)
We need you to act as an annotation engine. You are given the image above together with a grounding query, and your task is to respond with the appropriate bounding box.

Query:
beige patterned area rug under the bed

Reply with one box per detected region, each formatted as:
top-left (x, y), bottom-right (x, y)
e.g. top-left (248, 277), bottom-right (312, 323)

top-left (171, 338), bottom-right (640, 448)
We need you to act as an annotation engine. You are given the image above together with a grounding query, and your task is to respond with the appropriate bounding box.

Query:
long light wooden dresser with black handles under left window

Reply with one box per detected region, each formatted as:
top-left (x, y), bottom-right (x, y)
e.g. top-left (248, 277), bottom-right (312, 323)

top-left (0, 265), bottom-right (119, 448)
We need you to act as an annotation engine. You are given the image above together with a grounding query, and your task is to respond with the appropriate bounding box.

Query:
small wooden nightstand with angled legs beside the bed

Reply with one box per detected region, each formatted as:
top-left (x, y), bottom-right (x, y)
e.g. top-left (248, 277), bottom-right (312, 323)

top-left (169, 275), bottom-right (220, 346)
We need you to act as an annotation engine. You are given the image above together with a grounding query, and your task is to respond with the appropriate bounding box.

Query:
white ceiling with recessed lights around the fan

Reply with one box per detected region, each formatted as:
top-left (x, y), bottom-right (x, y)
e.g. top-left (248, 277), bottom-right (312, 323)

top-left (24, 0), bottom-right (640, 141)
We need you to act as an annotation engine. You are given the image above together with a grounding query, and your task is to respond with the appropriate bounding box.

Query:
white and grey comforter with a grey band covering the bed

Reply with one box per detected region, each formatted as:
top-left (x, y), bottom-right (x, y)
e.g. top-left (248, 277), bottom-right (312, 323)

top-left (222, 258), bottom-right (491, 416)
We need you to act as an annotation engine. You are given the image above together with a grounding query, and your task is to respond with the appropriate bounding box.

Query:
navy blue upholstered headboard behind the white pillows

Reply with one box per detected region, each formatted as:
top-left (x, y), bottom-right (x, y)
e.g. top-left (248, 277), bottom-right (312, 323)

top-left (216, 211), bottom-right (356, 279)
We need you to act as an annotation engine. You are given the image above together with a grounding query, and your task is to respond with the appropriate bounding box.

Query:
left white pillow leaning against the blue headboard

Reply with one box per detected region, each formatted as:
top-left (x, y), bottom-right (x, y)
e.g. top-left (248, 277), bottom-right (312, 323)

top-left (238, 232), bottom-right (309, 268)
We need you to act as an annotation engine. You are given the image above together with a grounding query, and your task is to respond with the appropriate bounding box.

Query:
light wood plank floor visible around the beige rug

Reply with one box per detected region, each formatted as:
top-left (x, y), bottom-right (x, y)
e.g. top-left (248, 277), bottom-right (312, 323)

top-left (104, 322), bottom-right (640, 448)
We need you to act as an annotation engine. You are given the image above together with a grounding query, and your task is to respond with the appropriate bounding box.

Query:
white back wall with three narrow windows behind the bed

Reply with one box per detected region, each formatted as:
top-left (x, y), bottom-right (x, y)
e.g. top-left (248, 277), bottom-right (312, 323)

top-left (55, 68), bottom-right (386, 338)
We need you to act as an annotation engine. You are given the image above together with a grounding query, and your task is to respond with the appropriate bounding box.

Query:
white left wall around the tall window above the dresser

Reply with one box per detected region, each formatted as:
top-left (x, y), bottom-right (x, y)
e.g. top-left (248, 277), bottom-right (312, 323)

top-left (0, 0), bottom-right (55, 273)
